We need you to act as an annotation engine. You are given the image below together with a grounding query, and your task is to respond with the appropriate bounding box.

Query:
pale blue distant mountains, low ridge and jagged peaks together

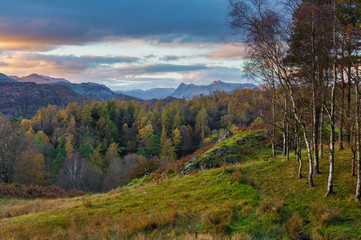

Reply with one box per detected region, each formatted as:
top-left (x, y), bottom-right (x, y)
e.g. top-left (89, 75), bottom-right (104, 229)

top-left (117, 80), bottom-right (258, 100)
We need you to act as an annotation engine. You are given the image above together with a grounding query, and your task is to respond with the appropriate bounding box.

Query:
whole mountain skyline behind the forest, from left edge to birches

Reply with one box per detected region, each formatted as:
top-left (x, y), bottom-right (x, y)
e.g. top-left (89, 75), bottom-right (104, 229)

top-left (0, 73), bottom-right (258, 117)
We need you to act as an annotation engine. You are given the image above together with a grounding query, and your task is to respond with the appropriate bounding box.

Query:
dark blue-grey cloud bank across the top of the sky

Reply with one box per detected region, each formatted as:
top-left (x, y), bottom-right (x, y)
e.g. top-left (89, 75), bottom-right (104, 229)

top-left (0, 0), bottom-right (229, 50)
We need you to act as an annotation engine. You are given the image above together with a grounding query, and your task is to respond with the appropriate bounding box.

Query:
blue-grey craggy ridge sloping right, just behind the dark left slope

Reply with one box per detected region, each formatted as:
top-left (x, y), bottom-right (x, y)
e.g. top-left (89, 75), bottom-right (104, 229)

top-left (52, 82), bottom-right (139, 101)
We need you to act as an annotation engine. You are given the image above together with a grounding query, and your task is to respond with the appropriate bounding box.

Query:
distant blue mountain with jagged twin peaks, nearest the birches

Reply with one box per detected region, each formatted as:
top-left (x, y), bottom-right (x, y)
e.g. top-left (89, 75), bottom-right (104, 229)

top-left (171, 80), bottom-right (258, 99)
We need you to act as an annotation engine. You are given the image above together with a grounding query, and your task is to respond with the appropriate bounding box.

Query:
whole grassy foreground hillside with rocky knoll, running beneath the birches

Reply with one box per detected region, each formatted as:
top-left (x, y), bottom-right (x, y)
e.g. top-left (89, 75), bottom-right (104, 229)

top-left (0, 131), bottom-right (361, 239)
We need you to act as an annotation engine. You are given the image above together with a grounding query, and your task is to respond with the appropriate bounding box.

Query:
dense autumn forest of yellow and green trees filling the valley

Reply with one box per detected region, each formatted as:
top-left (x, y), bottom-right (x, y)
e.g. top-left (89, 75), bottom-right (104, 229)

top-left (0, 89), bottom-right (270, 192)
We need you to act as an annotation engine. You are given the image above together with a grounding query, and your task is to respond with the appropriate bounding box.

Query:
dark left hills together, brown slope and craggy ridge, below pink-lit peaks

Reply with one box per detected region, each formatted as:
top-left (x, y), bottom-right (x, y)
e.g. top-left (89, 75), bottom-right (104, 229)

top-left (0, 80), bottom-right (139, 118)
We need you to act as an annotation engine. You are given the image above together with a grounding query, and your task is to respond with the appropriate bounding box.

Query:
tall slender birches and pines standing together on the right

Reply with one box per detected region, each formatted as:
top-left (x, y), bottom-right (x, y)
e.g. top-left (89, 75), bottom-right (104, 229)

top-left (229, 0), bottom-right (361, 201)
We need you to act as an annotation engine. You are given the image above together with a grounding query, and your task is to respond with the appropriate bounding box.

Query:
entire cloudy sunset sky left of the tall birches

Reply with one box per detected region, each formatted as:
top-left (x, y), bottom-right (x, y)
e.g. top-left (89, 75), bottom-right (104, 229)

top-left (0, 0), bottom-right (250, 90)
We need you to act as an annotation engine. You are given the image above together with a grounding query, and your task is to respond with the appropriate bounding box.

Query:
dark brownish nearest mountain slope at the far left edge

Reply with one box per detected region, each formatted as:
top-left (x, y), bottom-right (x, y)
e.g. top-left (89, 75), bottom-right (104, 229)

top-left (0, 82), bottom-right (91, 117)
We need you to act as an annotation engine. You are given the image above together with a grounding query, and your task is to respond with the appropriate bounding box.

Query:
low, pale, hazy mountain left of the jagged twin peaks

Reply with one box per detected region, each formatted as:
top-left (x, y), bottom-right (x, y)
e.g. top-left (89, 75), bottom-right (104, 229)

top-left (116, 88), bottom-right (175, 100)
